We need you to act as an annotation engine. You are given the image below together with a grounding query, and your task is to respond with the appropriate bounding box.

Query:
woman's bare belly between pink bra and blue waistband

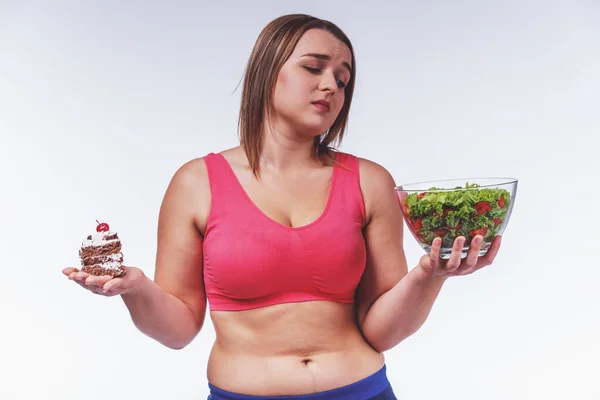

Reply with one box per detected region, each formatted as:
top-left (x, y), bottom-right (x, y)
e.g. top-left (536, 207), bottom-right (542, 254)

top-left (208, 301), bottom-right (384, 396)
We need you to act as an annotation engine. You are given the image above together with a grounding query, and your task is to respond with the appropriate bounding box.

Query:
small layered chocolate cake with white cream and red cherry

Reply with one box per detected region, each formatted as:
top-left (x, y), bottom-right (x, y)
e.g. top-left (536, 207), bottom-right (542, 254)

top-left (79, 221), bottom-right (125, 277)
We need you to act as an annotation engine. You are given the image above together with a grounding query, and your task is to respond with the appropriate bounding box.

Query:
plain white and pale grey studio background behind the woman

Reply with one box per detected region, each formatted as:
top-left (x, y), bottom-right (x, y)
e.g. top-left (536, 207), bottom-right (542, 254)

top-left (0, 0), bottom-right (600, 400)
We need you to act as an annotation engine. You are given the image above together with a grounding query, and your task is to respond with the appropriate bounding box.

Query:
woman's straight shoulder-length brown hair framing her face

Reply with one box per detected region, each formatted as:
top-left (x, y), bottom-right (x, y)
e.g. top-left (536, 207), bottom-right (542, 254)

top-left (238, 14), bottom-right (356, 177)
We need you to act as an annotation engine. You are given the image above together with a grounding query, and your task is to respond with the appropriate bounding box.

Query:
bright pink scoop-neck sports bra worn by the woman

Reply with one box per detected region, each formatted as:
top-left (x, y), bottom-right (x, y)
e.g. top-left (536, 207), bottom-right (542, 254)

top-left (203, 153), bottom-right (366, 311)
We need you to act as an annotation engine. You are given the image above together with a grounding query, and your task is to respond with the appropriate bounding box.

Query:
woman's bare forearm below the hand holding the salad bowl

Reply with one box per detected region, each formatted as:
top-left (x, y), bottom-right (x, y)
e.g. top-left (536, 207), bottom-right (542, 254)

top-left (361, 267), bottom-right (445, 352)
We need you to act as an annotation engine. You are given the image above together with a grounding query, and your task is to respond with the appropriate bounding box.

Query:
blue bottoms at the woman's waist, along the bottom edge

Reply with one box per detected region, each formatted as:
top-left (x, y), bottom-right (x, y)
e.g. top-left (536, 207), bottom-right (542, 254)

top-left (208, 365), bottom-right (397, 400)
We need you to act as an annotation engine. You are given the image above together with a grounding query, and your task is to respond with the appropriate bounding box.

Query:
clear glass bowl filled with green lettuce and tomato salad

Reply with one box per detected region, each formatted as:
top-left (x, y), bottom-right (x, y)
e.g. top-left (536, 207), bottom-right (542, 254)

top-left (395, 178), bottom-right (518, 259)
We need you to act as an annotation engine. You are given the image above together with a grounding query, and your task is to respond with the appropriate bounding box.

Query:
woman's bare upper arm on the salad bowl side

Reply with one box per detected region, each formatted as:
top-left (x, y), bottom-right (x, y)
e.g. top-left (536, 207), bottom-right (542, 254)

top-left (356, 159), bottom-right (408, 325)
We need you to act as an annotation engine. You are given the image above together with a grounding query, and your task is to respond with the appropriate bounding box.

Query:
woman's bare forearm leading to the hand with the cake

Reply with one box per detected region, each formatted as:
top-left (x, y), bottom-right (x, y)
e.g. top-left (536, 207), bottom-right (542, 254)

top-left (121, 277), bottom-right (201, 349)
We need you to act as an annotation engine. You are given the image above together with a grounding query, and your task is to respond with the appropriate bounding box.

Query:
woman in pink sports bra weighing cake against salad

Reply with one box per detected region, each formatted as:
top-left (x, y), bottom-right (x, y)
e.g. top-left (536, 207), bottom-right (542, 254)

top-left (64, 15), bottom-right (500, 399)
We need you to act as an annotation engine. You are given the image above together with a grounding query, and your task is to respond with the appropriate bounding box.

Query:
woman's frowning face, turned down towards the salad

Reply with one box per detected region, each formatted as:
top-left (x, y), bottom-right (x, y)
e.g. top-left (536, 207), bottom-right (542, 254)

top-left (271, 29), bottom-right (352, 139)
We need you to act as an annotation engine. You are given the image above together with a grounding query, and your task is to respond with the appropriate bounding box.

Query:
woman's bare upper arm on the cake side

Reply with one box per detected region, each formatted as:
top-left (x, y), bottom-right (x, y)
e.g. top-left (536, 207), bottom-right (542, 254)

top-left (154, 159), bottom-right (210, 328)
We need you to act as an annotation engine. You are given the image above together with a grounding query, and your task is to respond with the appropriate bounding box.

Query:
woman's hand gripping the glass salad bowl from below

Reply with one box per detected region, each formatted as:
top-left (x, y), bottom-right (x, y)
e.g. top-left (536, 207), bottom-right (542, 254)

top-left (418, 235), bottom-right (501, 278)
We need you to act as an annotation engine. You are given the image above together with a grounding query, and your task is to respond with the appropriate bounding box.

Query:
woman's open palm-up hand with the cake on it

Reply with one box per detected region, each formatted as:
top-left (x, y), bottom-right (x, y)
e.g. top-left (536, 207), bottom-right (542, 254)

top-left (62, 266), bottom-right (146, 297)
